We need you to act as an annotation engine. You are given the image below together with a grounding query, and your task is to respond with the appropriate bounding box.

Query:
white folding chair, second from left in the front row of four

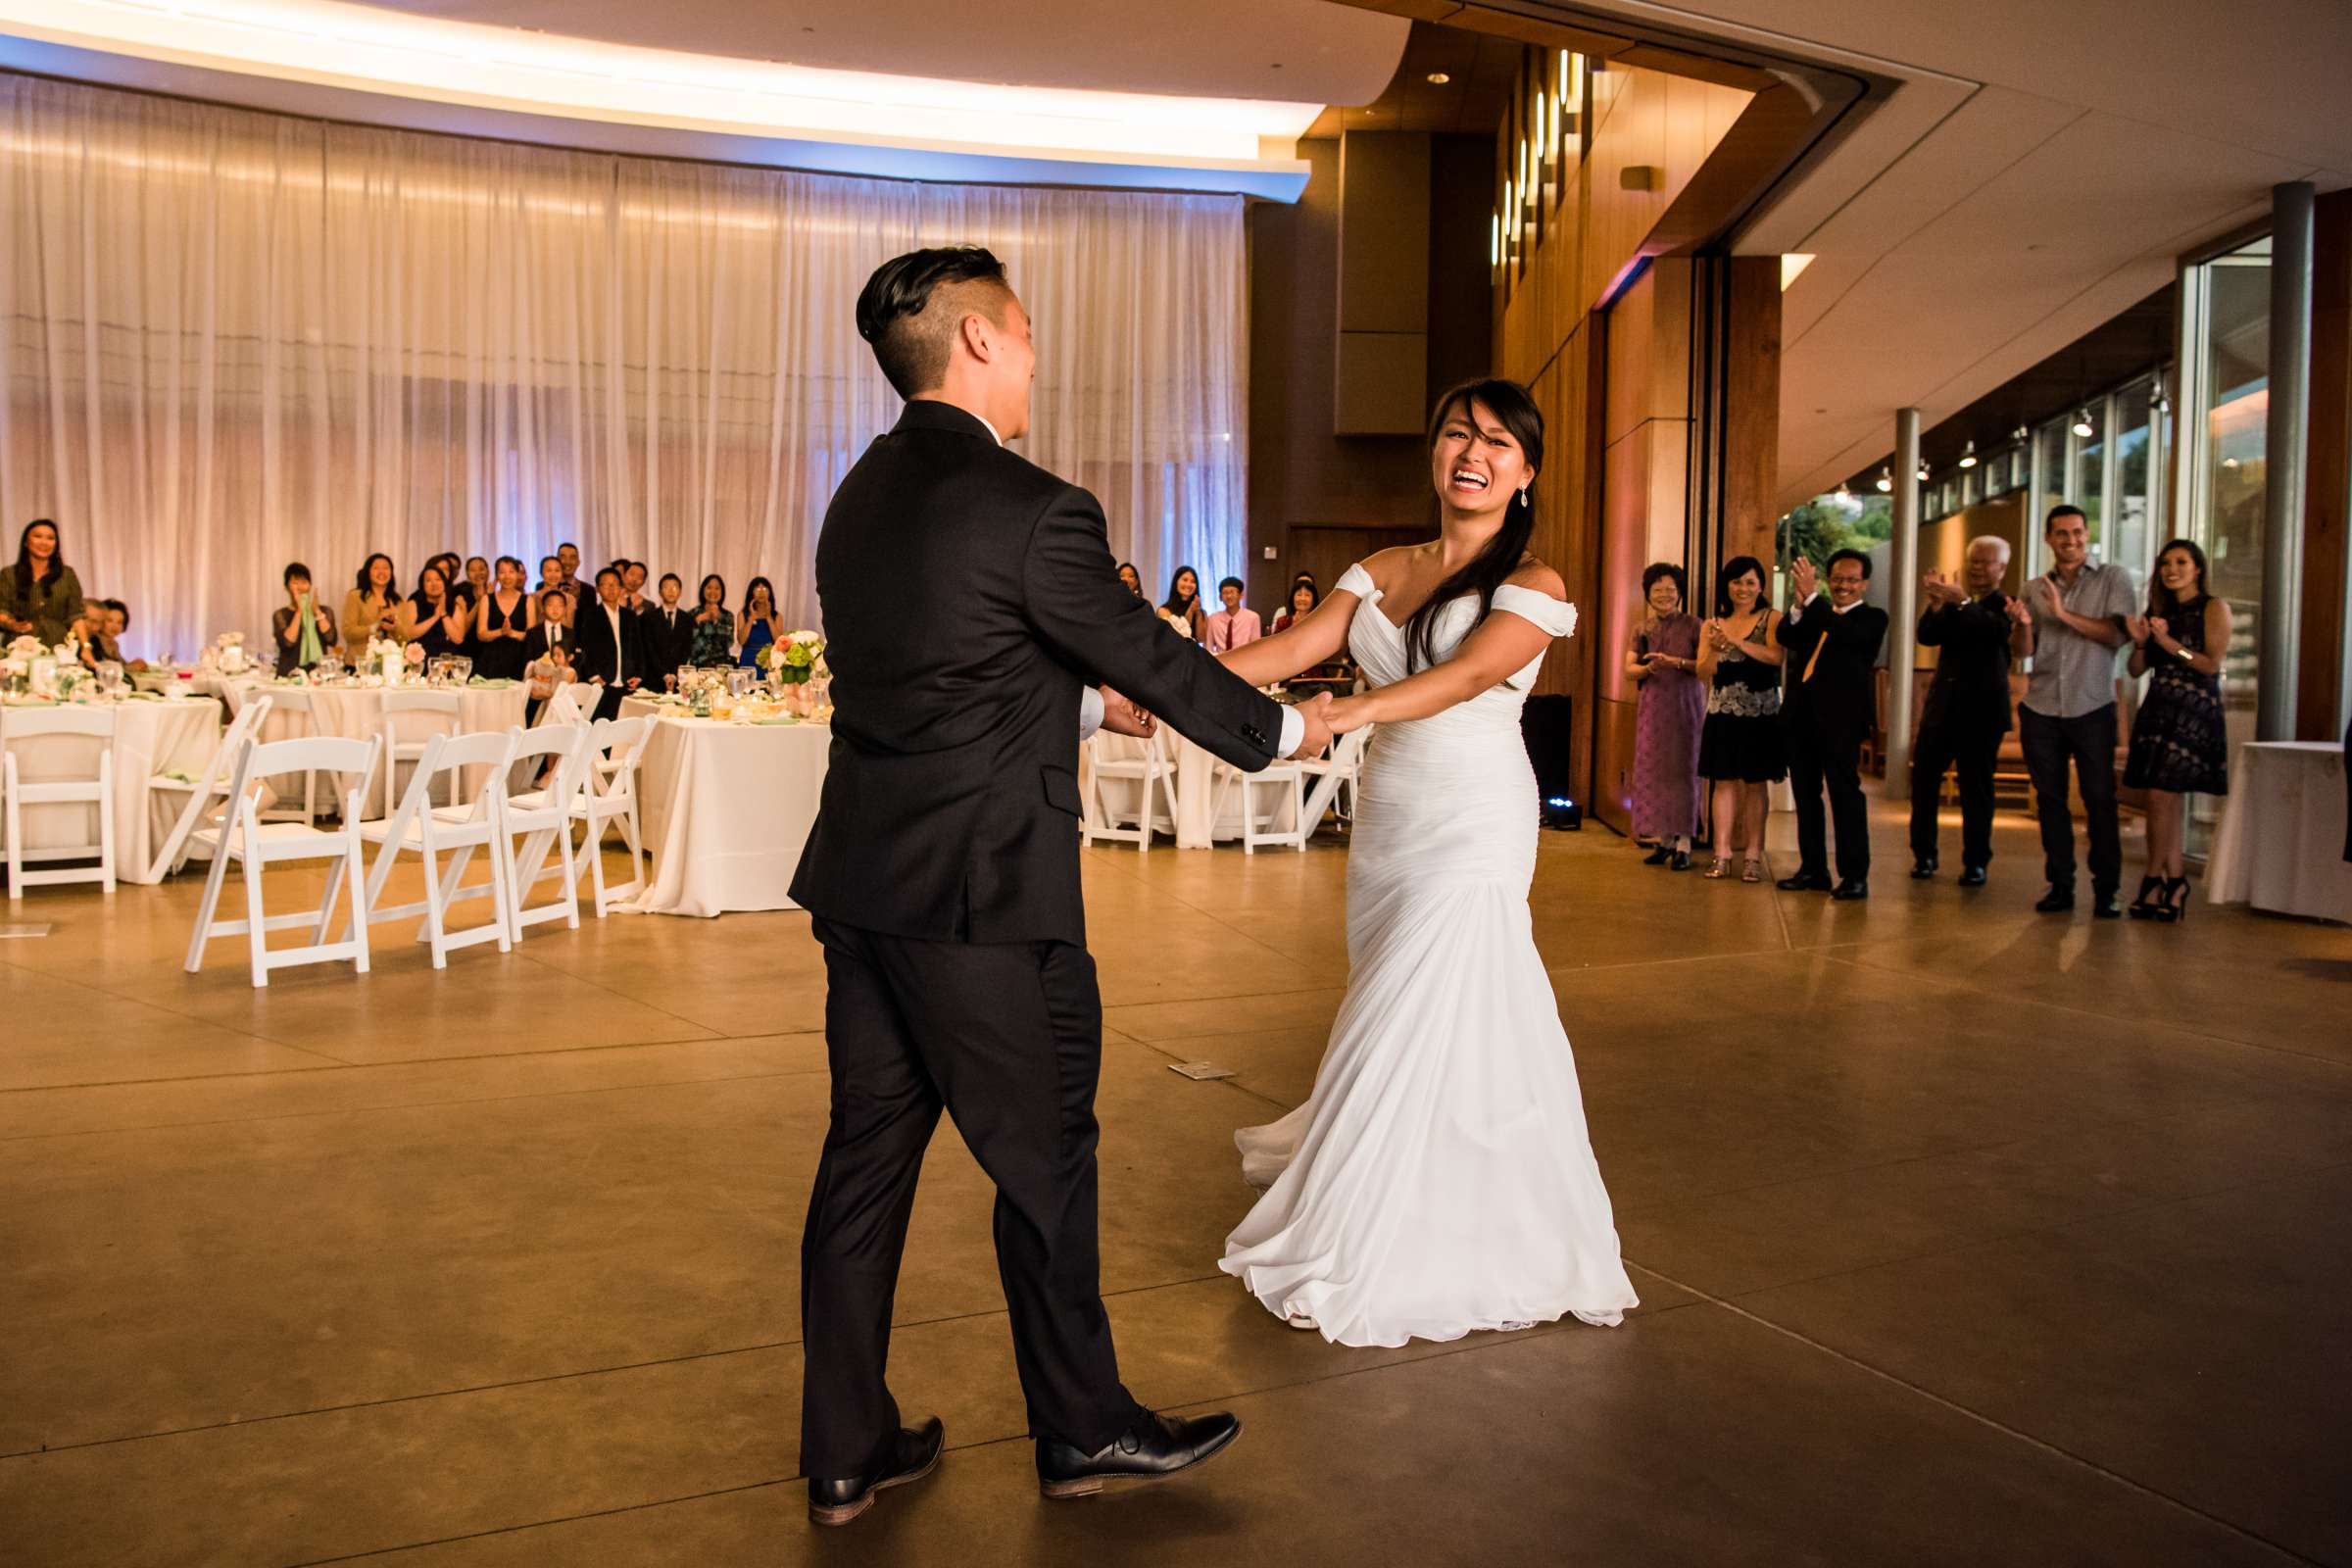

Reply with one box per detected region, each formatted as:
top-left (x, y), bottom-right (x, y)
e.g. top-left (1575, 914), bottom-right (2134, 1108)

top-left (360, 729), bottom-right (515, 968)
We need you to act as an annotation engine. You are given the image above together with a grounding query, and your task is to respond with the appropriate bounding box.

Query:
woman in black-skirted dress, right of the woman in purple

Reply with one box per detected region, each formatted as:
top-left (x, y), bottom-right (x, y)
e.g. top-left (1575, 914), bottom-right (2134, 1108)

top-left (1695, 555), bottom-right (1788, 882)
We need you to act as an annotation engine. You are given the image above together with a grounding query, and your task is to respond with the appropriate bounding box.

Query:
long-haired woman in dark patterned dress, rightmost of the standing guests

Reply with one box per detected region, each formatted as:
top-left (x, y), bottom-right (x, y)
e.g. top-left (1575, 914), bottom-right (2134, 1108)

top-left (2124, 538), bottom-right (2230, 921)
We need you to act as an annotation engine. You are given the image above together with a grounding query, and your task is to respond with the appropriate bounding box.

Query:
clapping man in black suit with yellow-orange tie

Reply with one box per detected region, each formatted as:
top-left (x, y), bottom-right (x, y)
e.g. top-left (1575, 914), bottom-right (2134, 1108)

top-left (1776, 550), bottom-right (1886, 901)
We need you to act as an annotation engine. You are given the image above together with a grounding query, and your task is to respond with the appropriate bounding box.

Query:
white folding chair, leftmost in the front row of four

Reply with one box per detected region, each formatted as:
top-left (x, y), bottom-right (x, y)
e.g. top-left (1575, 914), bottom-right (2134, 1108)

top-left (188, 736), bottom-right (383, 987)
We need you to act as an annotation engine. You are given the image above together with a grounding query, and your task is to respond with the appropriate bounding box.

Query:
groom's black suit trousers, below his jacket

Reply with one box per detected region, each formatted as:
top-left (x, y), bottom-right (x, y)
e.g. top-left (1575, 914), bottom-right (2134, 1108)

top-left (800, 919), bottom-right (1141, 1479)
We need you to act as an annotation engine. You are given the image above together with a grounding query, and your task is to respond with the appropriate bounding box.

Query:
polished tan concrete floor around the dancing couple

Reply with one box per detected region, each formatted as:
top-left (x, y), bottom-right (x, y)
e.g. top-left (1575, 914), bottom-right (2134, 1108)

top-left (0, 818), bottom-right (2352, 1568)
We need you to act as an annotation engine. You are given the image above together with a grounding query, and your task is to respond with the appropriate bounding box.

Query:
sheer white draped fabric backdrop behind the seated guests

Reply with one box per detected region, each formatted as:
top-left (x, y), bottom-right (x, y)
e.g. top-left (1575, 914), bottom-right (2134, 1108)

top-left (0, 73), bottom-right (1247, 659)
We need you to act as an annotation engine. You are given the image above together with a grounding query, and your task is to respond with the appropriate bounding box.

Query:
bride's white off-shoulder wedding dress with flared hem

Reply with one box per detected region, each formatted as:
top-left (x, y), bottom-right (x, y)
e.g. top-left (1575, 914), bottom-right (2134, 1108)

top-left (1218, 566), bottom-right (1637, 1345)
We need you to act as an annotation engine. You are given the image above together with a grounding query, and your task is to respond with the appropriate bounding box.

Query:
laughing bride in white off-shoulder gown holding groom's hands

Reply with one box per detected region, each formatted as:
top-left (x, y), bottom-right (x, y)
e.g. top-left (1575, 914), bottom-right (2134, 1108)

top-left (1218, 381), bottom-right (1637, 1345)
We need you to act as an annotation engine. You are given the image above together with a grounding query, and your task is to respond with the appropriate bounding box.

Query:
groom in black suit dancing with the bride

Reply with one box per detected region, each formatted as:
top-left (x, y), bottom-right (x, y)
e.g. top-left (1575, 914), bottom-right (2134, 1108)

top-left (793, 249), bottom-right (1329, 1523)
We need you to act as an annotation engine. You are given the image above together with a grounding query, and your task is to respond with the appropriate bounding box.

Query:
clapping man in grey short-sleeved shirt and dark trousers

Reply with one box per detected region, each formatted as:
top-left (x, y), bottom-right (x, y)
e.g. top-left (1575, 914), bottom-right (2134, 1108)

top-left (2009, 506), bottom-right (2138, 919)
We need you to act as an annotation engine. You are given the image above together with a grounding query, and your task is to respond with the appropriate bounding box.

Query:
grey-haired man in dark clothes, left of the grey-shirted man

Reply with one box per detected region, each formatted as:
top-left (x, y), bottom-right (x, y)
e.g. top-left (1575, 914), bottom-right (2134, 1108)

top-left (1912, 534), bottom-right (2023, 886)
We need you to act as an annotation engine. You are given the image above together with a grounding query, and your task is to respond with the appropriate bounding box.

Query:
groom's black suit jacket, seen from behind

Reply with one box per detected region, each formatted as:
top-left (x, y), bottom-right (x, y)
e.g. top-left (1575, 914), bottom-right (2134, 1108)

top-left (793, 400), bottom-right (1282, 943)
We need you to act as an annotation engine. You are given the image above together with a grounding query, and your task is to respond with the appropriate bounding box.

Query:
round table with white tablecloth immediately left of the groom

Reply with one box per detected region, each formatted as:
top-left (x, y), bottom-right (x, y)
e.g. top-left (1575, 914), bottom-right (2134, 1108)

top-left (621, 698), bottom-right (833, 914)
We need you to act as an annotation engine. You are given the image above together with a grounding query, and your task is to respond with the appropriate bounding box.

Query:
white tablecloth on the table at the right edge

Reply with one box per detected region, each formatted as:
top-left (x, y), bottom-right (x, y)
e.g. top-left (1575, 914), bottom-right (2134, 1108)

top-left (2206, 741), bottom-right (2352, 921)
